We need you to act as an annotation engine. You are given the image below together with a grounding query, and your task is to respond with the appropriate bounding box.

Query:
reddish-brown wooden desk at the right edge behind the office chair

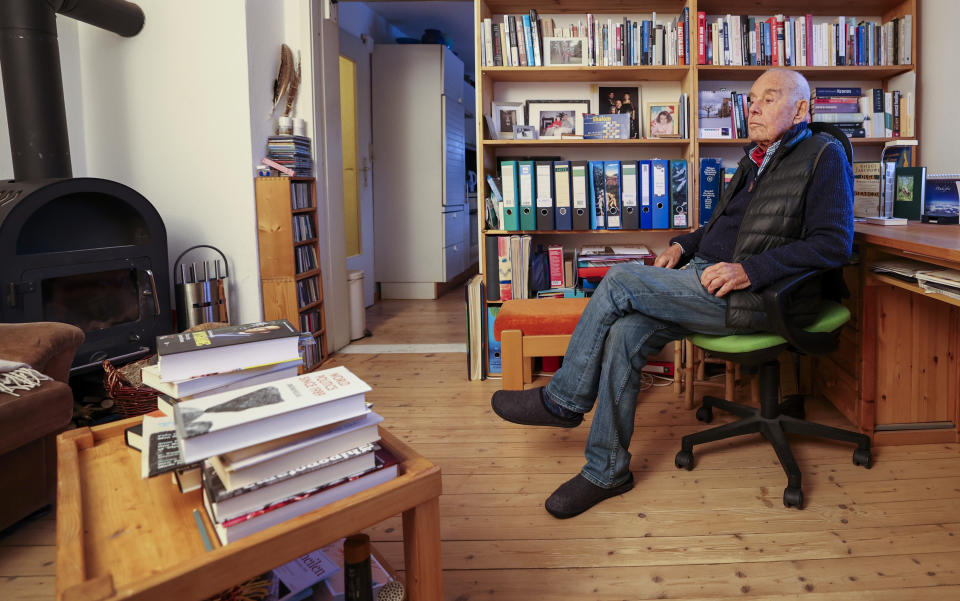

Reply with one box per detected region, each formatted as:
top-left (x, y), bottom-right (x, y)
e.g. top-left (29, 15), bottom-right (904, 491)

top-left (815, 222), bottom-right (960, 444)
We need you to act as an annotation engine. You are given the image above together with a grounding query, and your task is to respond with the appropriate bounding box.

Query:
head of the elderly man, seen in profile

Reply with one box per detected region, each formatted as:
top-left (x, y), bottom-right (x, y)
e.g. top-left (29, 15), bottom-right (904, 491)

top-left (747, 73), bottom-right (809, 147)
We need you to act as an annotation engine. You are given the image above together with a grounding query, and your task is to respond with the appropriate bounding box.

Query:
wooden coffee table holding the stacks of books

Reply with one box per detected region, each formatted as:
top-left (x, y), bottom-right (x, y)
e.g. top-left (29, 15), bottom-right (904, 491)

top-left (57, 418), bottom-right (442, 601)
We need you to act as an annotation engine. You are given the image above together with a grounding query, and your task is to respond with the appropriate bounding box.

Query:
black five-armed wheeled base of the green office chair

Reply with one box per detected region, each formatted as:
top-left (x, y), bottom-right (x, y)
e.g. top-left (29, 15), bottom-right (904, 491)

top-left (674, 362), bottom-right (873, 509)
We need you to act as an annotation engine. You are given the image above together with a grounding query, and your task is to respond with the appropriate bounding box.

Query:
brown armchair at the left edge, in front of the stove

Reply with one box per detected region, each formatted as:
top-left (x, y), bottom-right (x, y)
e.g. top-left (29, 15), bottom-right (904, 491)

top-left (0, 322), bottom-right (84, 529)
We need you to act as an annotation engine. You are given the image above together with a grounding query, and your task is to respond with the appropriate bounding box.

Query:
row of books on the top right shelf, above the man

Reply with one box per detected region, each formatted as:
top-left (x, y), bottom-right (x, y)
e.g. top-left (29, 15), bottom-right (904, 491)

top-left (697, 11), bottom-right (913, 67)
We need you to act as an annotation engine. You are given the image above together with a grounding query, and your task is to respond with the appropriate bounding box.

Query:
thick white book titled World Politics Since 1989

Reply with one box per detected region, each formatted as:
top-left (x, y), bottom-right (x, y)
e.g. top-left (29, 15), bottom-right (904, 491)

top-left (174, 366), bottom-right (370, 462)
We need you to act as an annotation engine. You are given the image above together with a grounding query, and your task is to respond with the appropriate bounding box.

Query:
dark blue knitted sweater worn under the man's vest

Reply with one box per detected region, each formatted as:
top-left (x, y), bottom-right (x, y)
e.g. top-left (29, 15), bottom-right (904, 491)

top-left (670, 128), bottom-right (853, 292)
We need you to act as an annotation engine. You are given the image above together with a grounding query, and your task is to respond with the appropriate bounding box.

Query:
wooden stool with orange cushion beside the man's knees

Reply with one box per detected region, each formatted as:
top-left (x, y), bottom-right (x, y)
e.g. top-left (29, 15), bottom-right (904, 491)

top-left (493, 298), bottom-right (590, 390)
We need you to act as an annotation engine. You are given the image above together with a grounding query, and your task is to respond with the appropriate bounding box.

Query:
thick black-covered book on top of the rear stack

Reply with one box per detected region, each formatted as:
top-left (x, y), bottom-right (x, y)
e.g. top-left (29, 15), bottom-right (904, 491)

top-left (157, 319), bottom-right (300, 382)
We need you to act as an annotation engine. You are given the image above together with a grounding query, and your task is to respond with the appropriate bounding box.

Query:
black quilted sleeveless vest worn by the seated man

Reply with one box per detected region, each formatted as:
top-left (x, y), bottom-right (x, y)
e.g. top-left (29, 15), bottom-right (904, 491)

top-left (704, 127), bottom-right (839, 331)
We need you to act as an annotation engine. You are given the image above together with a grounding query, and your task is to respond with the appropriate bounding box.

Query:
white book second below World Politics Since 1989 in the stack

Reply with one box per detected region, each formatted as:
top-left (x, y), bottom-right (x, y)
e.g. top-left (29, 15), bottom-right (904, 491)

top-left (207, 411), bottom-right (383, 490)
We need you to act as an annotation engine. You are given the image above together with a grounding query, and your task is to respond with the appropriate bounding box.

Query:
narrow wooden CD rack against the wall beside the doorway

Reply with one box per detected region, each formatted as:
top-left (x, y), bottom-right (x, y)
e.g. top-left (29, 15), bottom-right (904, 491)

top-left (255, 177), bottom-right (327, 371)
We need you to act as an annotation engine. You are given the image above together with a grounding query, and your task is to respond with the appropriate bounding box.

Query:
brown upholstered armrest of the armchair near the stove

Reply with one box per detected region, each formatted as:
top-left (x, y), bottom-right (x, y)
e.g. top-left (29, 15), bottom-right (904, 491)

top-left (0, 321), bottom-right (84, 382)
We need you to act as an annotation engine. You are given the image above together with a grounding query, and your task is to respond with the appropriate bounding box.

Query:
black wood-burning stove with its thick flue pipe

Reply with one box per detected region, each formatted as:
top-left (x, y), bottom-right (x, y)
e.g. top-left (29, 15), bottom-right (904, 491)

top-left (0, 0), bottom-right (172, 373)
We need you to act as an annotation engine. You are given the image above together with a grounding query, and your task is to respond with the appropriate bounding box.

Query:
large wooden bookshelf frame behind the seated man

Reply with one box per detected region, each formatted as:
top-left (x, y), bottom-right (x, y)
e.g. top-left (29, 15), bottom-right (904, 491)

top-left (474, 0), bottom-right (921, 376)
